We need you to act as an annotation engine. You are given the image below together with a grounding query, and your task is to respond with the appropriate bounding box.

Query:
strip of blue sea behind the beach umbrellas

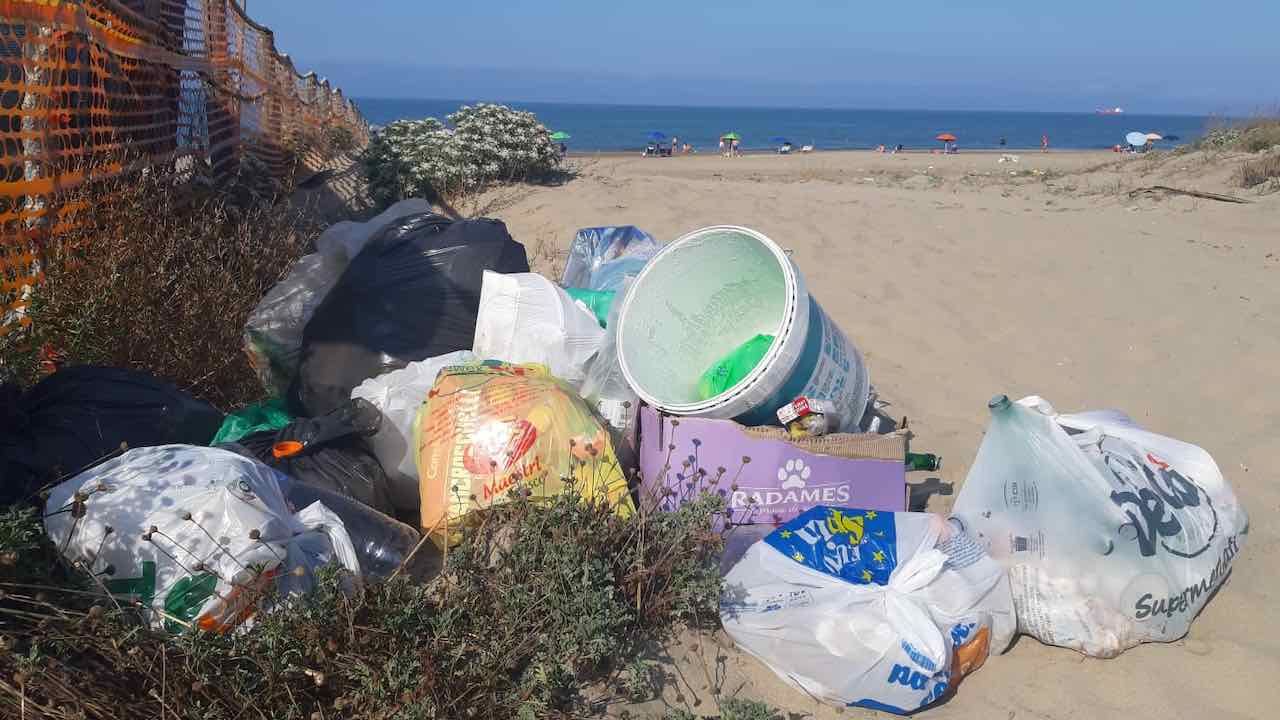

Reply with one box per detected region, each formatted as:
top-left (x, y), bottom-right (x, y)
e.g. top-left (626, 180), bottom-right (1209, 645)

top-left (356, 97), bottom-right (1219, 151)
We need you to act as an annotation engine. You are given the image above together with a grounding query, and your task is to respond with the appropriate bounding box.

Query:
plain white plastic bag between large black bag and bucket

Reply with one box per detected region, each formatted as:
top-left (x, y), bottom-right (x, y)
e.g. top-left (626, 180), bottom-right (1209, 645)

top-left (471, 270), bottom-right (604, 386)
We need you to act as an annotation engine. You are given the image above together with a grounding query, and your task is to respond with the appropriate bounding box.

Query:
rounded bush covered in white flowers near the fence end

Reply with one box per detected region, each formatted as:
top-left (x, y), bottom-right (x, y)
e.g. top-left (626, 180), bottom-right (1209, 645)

top-left (365, 102), bottom-right (559, 204)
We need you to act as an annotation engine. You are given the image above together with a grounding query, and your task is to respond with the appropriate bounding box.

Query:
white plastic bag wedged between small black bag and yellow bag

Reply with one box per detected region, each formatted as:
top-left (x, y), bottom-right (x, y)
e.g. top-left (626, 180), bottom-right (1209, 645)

top-left (351, 350), bottom-right (476, 510)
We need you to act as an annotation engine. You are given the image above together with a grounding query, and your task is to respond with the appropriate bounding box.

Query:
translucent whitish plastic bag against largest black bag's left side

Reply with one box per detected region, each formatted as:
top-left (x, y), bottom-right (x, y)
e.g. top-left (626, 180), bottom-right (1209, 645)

top-left (244, 199), bottom-right (431, 396)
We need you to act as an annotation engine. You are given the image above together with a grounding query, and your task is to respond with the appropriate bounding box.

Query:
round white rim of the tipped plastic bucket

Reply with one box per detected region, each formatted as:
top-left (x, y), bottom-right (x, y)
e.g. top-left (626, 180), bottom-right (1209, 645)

top-left (618, 224), bottom-right (808, 418)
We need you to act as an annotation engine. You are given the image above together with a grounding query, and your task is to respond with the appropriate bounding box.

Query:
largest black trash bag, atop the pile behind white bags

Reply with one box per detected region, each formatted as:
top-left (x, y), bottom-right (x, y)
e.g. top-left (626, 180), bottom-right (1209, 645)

top-left (289, 213), bottom-right (529, 416)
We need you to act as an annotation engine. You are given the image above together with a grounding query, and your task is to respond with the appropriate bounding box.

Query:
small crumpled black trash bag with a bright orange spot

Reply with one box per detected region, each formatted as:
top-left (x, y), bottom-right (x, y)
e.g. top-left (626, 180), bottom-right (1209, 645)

top-left (232, 398), bottom-right (394, 515)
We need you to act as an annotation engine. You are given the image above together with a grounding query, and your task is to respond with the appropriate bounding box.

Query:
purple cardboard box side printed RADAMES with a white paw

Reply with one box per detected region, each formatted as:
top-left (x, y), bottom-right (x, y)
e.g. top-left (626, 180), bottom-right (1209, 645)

top-left (640, 406), bottom-right (906, 524)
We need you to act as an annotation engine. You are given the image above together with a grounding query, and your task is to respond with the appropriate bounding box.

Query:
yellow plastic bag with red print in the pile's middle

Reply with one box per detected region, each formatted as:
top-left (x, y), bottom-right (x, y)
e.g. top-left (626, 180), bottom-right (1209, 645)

top-left (413, 361), bottom-right (631, 537)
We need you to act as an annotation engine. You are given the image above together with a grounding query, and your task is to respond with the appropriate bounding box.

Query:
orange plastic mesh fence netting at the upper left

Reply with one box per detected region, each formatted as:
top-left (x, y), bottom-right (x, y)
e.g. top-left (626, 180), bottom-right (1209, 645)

top-left (0, 0), bottom-right (367, 333)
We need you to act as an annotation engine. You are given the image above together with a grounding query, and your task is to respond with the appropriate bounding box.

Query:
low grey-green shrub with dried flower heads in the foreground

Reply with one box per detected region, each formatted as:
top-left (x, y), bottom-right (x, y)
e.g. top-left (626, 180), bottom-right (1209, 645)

top-left (0, 481), bottom-right (724, 720)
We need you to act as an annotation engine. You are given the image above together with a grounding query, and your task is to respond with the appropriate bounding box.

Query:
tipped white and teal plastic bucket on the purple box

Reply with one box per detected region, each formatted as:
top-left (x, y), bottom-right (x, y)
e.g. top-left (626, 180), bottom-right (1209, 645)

top-left (618, 225), bottom-right (870, 432)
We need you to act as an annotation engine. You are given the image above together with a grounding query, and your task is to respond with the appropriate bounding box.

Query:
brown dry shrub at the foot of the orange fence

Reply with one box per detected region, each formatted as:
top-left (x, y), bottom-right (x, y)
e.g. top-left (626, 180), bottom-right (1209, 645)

top-left (6, 163), bottom-right (315, 409)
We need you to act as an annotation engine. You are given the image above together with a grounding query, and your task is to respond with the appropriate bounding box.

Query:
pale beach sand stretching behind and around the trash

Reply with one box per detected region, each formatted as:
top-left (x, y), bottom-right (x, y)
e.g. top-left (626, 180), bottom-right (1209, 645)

top-left (463, 147), bottom-right (1280, 720)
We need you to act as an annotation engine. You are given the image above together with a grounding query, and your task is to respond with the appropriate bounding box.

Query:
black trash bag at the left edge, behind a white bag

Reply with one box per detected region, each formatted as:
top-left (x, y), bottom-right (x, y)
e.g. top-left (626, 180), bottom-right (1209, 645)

top-left (0, 365), bottom-right (223, 505)
